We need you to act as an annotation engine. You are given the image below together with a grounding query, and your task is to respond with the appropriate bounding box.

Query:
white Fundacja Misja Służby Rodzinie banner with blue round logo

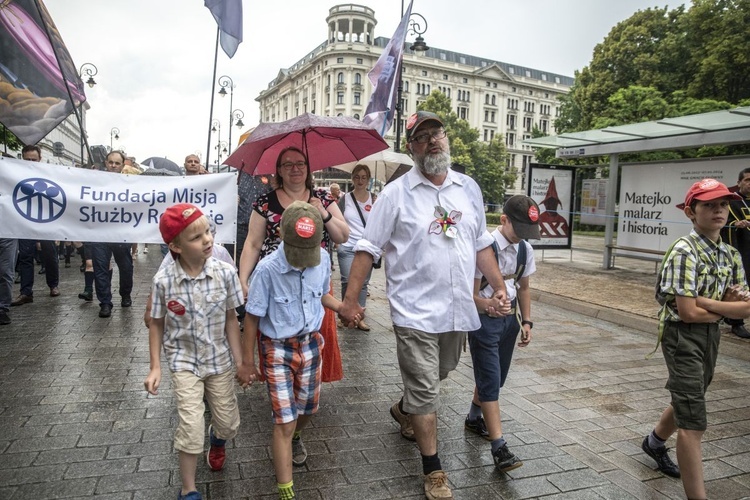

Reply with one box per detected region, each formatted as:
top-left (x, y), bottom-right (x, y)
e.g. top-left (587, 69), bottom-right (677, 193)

top-left (0, 158), bottom-right (237, 243)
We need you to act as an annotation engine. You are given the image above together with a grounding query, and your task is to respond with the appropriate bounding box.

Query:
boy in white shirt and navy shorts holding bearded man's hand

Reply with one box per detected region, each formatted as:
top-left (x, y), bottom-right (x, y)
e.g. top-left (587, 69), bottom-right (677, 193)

top-left (464, 195), bottom-right (539, 472)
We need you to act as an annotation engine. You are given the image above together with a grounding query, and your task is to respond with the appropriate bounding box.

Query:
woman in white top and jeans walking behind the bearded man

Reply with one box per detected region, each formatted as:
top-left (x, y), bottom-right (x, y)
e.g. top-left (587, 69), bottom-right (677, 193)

top-left (337, 163), bottom-right (377, 332)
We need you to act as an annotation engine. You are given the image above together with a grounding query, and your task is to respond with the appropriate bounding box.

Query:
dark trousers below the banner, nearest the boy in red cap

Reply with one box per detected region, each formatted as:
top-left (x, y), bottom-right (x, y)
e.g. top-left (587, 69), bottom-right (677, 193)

top-left (86, 243), bottom-right (133, 306)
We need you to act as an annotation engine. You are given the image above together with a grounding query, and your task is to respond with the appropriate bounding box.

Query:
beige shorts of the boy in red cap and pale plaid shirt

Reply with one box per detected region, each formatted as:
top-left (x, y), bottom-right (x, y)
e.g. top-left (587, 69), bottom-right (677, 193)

top-left (172, 370), bottom-right (240, 455)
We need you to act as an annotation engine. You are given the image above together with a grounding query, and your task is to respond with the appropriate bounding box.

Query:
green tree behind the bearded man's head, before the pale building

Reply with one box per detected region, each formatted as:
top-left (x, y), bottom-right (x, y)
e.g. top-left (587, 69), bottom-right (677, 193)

top-left (418, 90), bottom-right (517, 205)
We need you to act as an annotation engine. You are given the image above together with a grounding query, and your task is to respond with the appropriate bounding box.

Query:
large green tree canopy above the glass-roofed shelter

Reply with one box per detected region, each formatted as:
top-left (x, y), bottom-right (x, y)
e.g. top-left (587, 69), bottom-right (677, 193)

top-left (555, 0), bottom-right (750, 133)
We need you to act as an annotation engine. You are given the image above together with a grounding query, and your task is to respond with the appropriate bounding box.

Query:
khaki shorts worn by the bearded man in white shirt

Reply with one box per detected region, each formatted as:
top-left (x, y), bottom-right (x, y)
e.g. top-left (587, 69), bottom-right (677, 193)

top-left (393, 325), bottom-right (466, 415)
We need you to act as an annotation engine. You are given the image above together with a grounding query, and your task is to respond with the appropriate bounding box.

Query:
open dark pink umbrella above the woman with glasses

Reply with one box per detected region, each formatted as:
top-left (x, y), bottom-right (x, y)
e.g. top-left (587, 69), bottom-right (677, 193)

top-left (224, 113), bottom-right (388, 175)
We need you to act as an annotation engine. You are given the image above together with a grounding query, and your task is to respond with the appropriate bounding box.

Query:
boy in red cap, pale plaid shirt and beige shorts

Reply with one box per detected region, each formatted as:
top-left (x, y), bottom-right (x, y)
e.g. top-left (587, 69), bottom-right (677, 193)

top-left (143, 203), bottom-right (243, 500)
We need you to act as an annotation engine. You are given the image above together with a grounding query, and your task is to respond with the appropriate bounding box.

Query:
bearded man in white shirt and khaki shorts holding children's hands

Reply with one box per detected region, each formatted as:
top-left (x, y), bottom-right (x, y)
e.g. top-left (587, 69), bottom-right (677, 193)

top-left (340, 111), bottom-right (506, 499)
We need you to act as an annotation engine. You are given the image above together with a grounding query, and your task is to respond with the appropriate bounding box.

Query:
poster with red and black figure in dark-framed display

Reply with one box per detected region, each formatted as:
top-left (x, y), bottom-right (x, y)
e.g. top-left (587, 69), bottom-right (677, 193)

top-left (528, 163), bottom-right (575, 248)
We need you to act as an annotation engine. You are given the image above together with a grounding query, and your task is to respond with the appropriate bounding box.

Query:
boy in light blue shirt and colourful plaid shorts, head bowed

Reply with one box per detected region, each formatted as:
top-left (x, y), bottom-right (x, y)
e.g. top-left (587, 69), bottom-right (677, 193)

top-left (237, 201), bottom-right (356, 500)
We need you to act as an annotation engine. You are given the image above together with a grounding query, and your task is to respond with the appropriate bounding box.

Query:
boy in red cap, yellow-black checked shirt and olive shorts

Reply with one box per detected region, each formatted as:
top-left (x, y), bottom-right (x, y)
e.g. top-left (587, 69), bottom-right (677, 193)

top-left (641, 179), bottom-right (750, 499)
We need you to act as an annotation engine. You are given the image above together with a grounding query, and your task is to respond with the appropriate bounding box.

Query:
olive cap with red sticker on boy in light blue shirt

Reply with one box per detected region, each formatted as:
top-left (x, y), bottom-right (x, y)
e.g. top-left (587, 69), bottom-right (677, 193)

top-left (281, 201), bottom-right (323, 269)
